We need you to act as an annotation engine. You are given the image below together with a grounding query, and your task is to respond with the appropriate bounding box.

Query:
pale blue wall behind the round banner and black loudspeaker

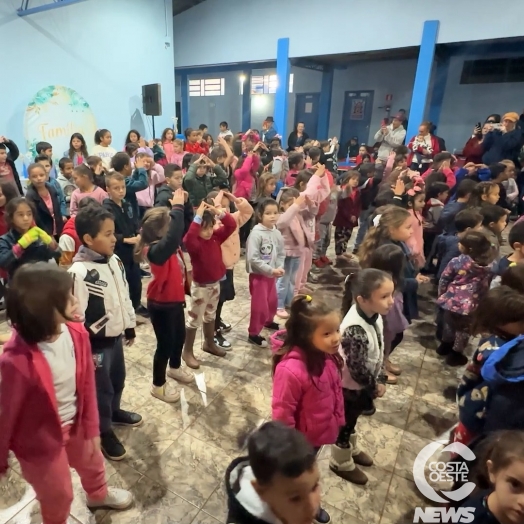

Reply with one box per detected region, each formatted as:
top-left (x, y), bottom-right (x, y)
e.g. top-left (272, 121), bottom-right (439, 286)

top-left (0, 0), bottom-right (175, 162)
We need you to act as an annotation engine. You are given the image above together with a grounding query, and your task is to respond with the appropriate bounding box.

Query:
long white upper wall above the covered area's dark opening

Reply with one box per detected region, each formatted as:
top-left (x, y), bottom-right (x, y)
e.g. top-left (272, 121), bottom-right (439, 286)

top-left (173, 0), bottom-right (524, 67)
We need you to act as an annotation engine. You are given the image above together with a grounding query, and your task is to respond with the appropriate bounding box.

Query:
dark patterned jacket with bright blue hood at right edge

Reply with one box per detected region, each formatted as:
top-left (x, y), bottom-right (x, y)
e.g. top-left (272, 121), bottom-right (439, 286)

top-left (457, 335), bottom-right (524, 434)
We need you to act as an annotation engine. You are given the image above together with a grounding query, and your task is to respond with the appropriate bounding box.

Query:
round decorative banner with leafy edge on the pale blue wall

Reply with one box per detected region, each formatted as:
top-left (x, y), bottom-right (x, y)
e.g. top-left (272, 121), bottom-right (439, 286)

top-left (24, 86), bottom-right (97, 164)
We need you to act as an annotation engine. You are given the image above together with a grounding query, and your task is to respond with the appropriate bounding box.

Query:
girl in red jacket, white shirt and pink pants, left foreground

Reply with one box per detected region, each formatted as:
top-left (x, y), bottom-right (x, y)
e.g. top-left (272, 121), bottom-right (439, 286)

top-left (0, 262), bottom-right (133, 524)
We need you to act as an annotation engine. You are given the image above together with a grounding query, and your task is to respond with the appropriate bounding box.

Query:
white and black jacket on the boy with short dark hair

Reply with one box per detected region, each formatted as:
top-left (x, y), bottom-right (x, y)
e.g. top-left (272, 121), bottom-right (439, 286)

top-left (68, 246), bottom-right (136, 338)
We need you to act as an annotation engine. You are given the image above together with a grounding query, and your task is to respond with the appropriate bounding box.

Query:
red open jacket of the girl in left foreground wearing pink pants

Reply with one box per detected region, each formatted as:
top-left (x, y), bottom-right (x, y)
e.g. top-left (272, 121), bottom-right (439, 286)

top-left (0, 323), bottom-right (100, 475)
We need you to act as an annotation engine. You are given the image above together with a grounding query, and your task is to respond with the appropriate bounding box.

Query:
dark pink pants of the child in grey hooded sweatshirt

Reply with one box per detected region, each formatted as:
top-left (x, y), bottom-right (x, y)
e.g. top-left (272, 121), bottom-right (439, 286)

top-left (249, 273), bottom-right (277, 335)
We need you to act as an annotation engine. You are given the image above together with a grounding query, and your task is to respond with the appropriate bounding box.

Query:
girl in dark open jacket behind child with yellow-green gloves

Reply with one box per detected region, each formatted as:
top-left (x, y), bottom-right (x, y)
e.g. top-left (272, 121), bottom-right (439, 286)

top-left (26, 164), bottom-right (64, 239)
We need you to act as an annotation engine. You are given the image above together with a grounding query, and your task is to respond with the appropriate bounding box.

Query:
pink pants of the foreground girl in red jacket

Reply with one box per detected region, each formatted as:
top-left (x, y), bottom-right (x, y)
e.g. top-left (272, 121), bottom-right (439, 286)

top-left (20, 425), bottom-right (107, 524)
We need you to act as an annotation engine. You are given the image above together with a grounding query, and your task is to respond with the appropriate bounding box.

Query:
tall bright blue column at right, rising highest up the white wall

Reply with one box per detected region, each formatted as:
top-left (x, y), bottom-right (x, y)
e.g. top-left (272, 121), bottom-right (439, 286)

top-left (406, 20), bottom-right (440, 142)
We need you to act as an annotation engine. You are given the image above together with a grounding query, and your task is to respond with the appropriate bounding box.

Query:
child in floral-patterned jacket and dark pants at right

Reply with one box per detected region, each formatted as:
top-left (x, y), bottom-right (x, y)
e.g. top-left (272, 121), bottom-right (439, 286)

top-left (437, 231), bottom-right (496, 366)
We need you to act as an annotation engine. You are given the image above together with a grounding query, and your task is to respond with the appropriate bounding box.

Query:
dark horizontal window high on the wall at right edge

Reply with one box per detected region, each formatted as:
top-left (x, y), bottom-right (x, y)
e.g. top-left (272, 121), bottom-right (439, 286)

top-left (460, 57), bottom-right (524, 84)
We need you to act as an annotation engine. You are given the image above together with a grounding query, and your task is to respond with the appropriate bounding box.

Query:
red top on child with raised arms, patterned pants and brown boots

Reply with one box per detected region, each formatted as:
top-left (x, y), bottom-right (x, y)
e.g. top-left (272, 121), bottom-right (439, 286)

top-left (184, 213), bottom-right (237, 284)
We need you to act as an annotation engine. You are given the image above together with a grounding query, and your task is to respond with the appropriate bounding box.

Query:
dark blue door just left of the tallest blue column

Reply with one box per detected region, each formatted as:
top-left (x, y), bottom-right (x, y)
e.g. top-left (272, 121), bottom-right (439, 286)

top-left (340, 91), bottom-right (375, 156)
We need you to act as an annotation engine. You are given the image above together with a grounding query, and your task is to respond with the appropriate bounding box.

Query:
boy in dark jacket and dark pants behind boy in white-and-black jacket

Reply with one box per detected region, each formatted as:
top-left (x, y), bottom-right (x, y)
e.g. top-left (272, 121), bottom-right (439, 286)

top-left (103, 173), bottom-right (149, 318)
